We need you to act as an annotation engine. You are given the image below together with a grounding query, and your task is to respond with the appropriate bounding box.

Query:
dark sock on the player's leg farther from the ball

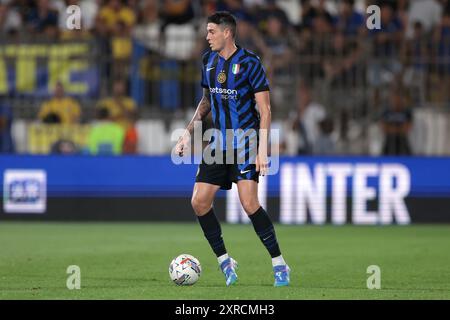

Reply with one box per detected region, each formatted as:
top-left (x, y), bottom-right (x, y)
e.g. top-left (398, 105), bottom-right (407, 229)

top-left (249, 207), bottom-right (281, 258)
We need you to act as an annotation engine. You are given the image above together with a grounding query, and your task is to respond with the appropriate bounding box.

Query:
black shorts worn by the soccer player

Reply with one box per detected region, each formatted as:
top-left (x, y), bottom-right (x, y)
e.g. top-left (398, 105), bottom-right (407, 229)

top-left (195, 150), bottom-right (259, 190)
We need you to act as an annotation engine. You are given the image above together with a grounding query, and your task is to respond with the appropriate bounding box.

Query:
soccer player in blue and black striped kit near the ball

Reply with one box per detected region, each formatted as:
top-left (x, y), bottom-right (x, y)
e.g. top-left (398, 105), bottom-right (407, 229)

top-left (175, 12), bottom-right (290, 287)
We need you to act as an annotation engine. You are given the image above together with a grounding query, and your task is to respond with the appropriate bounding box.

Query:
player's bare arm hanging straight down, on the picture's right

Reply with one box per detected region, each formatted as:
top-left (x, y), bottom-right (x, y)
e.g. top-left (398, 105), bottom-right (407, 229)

top-left (255, 91), bottom-right (272, 176)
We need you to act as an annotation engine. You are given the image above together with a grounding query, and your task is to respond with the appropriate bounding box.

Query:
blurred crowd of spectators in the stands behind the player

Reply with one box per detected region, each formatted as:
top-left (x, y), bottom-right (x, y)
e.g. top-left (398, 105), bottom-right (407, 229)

top-left (0, 0), bottom-right (450, 155)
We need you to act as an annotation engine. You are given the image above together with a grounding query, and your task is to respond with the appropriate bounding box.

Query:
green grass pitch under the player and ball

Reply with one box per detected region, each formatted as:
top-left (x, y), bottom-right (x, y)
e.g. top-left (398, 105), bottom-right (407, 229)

top-left (0, 221), bottom-right (450, 300)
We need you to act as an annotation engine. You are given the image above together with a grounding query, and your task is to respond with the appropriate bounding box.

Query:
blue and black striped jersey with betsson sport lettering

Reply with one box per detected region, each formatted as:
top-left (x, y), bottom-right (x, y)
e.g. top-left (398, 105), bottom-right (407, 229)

top-left (201, 46), bottom-right (269, 150)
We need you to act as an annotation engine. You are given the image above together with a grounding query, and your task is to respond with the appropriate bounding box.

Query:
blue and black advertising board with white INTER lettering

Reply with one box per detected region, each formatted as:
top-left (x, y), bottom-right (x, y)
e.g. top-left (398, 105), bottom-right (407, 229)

top-left (0, 156), bottom-right (450, 225)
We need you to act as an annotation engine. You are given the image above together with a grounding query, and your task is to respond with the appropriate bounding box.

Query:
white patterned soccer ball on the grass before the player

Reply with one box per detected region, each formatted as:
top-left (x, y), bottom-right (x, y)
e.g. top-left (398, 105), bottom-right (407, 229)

top-left (169, 254), bottom-right (202, 286)
